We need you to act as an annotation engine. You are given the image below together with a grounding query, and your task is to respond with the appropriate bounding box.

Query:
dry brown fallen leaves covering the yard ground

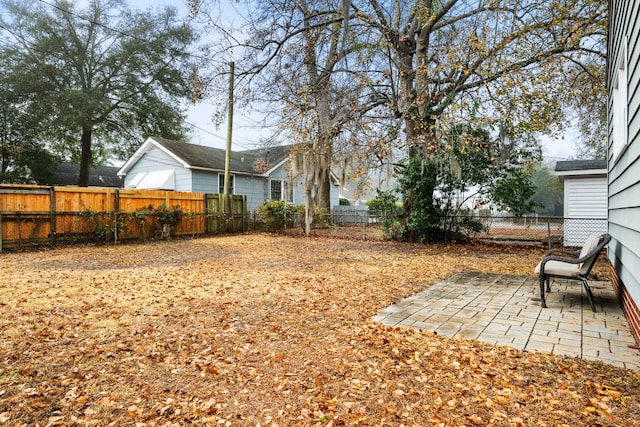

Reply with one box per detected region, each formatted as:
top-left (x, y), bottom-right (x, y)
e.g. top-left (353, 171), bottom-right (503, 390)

top-left (0, 235), bottom-right (640, 427)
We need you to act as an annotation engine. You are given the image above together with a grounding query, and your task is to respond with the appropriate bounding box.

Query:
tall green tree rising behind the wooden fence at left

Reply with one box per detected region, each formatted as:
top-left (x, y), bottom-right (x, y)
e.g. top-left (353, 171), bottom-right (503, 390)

top-left (0, 0), bottom-right (195, 186)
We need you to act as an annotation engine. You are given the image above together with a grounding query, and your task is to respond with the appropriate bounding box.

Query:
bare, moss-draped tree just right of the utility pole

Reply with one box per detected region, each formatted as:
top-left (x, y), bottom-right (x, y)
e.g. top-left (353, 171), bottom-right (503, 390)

top-left (195, 0), bottom-right (372, 233)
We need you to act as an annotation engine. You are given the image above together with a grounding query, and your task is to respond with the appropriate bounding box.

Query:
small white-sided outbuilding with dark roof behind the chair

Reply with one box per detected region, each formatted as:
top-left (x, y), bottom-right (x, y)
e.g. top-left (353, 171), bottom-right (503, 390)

top-left (555, 160), bottom-right (607, 246)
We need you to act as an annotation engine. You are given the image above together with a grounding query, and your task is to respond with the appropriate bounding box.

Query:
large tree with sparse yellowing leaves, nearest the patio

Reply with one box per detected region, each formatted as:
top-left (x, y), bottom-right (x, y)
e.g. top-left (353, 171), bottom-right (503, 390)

top-left (350, 0), bottom-right (607, 241)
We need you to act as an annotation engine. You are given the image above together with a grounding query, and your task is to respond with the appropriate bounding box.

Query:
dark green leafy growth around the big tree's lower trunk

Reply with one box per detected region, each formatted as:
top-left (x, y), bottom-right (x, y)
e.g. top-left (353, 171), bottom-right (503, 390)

top-left (399, 124), bottom-right (533, 242)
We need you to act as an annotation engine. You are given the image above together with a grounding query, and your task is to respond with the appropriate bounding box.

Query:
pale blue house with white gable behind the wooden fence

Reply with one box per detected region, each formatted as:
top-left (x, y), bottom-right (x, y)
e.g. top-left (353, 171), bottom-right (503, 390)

top-left (118, 137), bottom-right (338, 211)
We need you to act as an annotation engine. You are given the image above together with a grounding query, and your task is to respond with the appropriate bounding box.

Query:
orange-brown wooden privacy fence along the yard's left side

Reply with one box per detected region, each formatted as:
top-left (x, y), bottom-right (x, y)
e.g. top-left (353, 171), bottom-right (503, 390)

top-left (0, 184), bottom-right (248, 251)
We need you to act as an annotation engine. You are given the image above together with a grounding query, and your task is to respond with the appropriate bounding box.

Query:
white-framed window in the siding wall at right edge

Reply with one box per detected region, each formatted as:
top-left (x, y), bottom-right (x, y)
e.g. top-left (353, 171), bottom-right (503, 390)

top-left (610, 38), bottom-right (629, 161)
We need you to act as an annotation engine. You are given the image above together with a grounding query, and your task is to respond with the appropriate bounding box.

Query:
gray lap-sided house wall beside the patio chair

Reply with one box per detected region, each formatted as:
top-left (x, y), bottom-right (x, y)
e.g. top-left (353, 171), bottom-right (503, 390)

top-left (607, 0), bottom-right (640, 341)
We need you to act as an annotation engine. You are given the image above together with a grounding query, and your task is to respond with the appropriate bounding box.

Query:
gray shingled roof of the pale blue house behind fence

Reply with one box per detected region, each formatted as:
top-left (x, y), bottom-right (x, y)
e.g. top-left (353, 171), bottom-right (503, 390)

top-left (118, 137), bottom-right (291, 176)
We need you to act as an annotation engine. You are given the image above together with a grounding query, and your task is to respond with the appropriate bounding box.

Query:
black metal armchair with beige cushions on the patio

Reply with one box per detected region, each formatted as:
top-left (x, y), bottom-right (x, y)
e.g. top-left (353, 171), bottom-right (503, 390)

top-left (534, 233), bottom-right (611, 312)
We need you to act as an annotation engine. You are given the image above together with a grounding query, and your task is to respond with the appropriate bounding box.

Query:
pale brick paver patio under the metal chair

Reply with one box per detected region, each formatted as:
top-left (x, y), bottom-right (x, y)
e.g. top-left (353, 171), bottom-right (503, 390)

top-left (373, 272), bottom-right (640, 370)
